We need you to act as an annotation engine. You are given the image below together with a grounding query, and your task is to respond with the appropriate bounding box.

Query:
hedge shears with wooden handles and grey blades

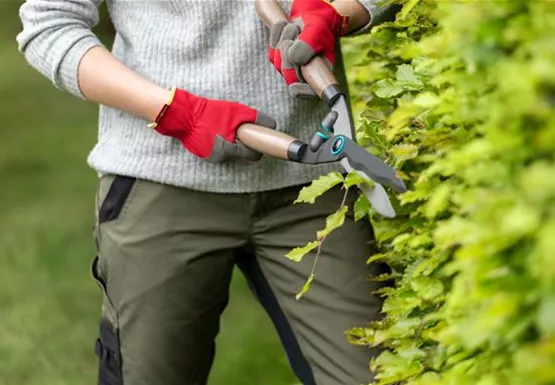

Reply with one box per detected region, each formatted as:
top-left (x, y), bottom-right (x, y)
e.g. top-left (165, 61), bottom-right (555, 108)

top-left (237, 0), bottom-right (406, 218)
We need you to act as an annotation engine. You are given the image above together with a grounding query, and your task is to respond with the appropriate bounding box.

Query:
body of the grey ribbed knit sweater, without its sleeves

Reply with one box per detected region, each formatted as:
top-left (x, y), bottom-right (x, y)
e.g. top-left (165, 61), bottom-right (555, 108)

top-left (89, 0), bottom-right (343, 191)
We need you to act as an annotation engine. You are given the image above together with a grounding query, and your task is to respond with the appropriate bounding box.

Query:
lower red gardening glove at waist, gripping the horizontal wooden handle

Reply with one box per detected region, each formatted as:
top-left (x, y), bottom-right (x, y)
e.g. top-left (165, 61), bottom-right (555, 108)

top-left (151, 89), bottom-right (276, 163)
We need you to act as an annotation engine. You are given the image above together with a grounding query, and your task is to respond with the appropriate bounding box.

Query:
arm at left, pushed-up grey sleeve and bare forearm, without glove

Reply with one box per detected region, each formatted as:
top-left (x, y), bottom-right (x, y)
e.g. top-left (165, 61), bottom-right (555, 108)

top-left (17, 0), bottom-right (170, 121)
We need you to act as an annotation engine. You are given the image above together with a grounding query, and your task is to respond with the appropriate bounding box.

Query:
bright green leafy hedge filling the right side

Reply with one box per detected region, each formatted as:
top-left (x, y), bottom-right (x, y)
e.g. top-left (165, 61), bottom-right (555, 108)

top-left (293, 0), bottom-right (555, 385)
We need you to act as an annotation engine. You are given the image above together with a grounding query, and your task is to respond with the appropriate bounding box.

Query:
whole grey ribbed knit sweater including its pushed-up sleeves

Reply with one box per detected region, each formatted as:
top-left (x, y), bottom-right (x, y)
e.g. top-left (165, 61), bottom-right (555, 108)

top-left (17, 0), bottom-right (396, 192)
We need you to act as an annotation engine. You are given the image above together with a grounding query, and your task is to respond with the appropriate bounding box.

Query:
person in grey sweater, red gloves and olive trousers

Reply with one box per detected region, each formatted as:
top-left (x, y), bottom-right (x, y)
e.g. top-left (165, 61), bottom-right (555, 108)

top-left (17, 0), bottom-right (400, 385)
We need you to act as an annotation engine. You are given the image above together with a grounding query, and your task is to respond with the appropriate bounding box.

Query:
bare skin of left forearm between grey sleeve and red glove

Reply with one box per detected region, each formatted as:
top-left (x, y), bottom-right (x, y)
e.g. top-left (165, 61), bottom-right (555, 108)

top-left (78, 47), bottom-right (171, 121)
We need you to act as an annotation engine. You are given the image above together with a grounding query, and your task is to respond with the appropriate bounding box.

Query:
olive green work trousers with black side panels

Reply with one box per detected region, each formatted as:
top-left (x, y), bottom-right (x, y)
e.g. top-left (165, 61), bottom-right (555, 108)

top-left (91, 176), bottom-right (381, 385)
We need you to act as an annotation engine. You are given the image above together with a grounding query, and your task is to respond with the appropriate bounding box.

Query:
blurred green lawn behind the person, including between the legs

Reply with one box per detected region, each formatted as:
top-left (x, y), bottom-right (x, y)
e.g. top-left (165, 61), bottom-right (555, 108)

top-left (0, 0), bottom-right (304, 385)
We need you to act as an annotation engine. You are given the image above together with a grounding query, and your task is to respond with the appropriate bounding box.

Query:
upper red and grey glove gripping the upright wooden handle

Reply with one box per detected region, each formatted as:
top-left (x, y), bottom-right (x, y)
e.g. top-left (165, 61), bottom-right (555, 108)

top-left (268, 0), bottom-right (349, 98)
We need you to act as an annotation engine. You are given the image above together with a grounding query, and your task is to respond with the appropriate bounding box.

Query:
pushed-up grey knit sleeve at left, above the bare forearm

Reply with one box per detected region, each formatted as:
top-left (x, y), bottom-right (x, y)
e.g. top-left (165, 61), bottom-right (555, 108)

top-left (16, 0), bottom-right (103, 99)
